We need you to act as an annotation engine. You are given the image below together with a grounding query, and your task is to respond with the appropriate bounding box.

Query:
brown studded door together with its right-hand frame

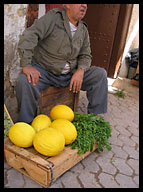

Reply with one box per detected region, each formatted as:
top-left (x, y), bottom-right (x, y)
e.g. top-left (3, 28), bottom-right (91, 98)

top-left (83, 4), bottom-right (133, 77)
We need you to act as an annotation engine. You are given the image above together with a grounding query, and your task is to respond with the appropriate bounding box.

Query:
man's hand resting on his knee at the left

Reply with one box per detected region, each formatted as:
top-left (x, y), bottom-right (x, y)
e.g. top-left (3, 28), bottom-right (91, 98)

top-left (22, 66), bottom-right (41, 86)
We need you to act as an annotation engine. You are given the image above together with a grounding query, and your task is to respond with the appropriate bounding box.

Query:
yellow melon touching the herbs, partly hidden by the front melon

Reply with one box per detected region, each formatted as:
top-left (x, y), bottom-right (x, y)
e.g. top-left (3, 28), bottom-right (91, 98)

top-left (51, 119), bottom-right (77, 145)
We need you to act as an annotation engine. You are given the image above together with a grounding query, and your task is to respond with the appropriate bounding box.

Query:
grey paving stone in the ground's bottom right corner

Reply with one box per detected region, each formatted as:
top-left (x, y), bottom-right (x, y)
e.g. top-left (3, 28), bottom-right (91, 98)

top-left (115, 173), bottom-right (138, 188)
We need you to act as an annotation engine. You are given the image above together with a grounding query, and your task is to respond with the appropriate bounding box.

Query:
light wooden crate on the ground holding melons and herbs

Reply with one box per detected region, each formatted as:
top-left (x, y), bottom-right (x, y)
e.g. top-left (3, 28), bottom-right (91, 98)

top-left (4, 138), bottom-right (97, 188)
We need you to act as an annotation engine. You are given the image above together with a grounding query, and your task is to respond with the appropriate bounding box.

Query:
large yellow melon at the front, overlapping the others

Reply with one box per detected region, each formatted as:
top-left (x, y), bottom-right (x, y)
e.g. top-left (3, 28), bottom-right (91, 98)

top-left (33, 127), bottom-right (65, 156)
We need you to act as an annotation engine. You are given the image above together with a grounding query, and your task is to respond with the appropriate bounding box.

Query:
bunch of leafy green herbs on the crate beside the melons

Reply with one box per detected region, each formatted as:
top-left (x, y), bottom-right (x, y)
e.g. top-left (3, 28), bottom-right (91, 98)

top-left (70, 112), bottom-right (111, 154)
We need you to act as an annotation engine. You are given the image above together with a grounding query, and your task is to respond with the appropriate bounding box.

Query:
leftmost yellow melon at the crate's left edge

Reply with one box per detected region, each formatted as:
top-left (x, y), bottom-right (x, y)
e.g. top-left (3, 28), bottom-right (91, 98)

top-left (8, 122), bottom-right (36, 147)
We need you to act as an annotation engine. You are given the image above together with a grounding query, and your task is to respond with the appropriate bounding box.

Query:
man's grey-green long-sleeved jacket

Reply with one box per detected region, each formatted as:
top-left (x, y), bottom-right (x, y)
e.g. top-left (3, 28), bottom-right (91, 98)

top-left (18, 8), bottom-right (92, 75)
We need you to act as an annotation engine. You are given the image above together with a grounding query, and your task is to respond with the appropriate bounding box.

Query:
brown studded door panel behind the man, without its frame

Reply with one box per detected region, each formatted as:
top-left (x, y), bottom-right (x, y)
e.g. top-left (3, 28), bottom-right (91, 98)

top-left (83, 4), bottom-right (120, 75)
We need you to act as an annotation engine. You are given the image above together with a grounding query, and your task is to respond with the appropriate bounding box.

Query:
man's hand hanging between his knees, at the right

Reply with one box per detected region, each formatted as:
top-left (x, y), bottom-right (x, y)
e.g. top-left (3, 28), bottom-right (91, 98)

top-left (70, 69), bottom-right (84, 93)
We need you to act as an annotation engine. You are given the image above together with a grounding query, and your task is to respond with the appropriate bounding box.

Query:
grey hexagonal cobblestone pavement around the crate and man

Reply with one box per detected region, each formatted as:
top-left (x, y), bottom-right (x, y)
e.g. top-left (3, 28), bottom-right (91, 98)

top-left (4, 79), bottom-right (139, 188)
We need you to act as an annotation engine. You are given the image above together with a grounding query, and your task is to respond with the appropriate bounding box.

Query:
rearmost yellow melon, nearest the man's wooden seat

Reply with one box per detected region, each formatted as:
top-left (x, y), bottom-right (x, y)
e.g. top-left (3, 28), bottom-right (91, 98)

top-left (50, 105), bottom-right (74, 121)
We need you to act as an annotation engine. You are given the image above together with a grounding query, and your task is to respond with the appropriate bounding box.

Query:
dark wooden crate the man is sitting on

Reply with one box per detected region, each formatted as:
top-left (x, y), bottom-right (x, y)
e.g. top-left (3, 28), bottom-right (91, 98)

top-left (37, 86), bottom-right (79, 116)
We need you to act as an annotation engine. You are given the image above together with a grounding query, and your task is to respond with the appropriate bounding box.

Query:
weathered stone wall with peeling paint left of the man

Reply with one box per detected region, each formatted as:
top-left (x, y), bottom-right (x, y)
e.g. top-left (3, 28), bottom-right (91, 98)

top-left (4, 4), bottom-right (28, 121)
